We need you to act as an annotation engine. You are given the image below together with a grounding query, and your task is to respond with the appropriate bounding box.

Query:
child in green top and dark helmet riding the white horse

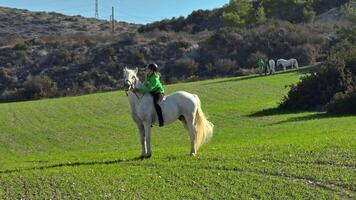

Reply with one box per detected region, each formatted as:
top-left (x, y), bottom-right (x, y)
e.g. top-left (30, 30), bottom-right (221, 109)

top-left (136, 63), bottom-right (164, 126)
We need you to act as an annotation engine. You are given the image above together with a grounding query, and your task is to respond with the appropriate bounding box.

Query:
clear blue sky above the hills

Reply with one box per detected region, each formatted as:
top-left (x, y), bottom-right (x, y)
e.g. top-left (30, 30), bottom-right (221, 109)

top-left (0, 0), bottom-right (229, 23)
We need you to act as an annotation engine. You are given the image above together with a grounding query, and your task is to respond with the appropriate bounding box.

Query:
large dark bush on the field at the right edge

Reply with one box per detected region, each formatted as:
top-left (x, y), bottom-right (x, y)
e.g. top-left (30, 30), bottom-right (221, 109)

top-left (280, 27), bottom-right (356, 113)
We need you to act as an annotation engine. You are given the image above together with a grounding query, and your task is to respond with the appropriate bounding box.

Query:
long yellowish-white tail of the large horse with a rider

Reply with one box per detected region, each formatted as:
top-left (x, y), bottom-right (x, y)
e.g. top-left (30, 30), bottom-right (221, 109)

top-left (195, 95), bottom-right (214, 150)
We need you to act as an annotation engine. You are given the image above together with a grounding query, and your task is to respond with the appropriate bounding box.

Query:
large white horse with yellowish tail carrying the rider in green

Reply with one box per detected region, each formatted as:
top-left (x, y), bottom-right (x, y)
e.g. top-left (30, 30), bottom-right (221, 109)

top-left (124, 68), bottom-right (214, 159)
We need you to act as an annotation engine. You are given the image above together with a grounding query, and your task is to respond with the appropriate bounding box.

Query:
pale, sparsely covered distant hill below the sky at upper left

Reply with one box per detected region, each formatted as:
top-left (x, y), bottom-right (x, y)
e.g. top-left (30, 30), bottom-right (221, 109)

top-left (0, 7), bottom-right (139, 38)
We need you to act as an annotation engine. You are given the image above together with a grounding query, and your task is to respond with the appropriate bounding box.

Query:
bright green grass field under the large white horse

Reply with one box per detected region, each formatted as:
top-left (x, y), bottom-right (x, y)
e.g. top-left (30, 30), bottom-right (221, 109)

top-left (0, 72), bottom-right (356, 199)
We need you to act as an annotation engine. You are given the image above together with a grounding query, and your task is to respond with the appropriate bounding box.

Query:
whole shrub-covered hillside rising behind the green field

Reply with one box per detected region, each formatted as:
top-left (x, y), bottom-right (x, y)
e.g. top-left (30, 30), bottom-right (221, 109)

top-left (0, 0), bottom-right (347, 102)
